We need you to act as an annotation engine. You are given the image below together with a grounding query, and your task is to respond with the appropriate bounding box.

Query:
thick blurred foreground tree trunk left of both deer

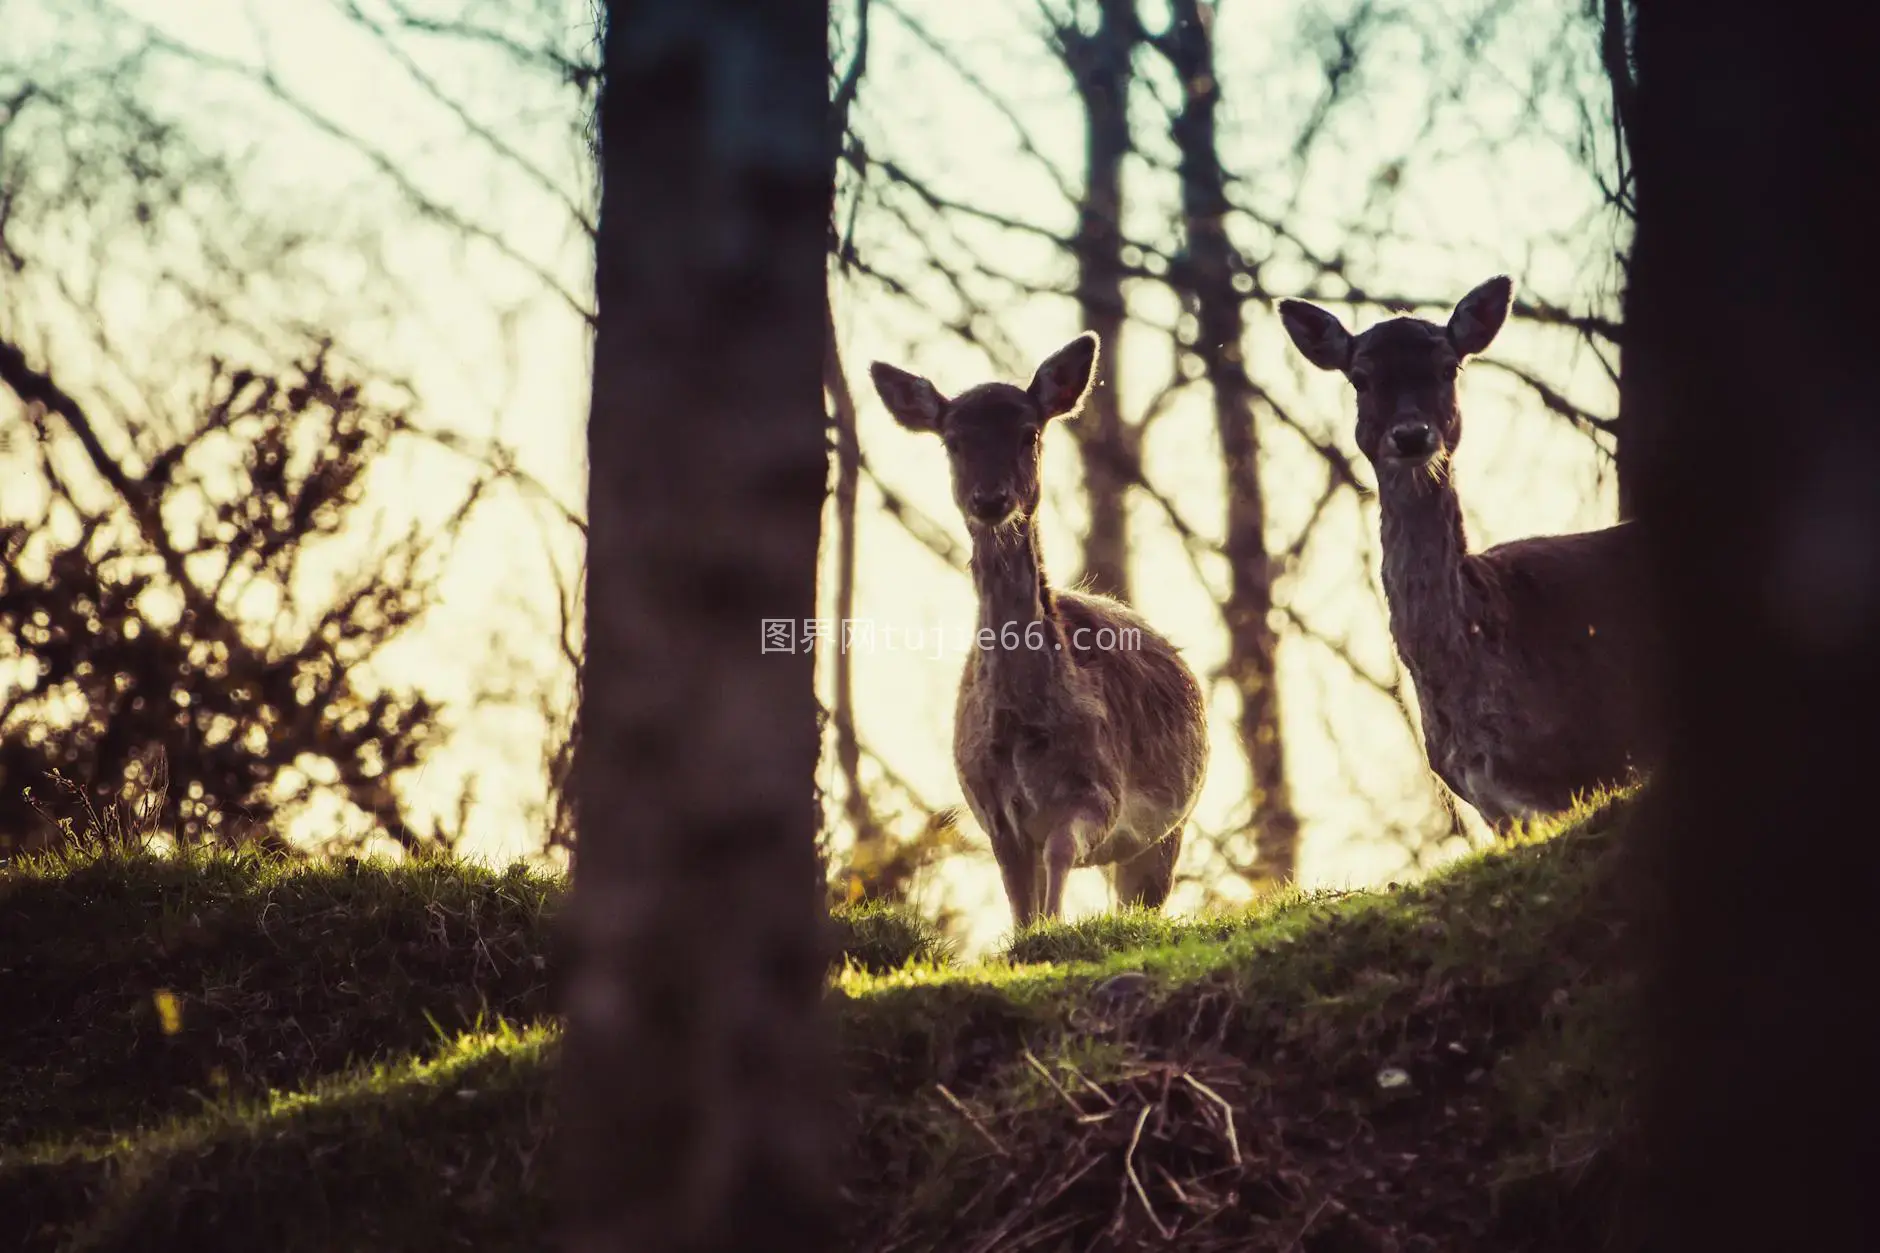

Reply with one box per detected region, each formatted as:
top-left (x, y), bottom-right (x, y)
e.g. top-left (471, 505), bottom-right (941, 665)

top-left (558, 0), bottom-right (833, 1253)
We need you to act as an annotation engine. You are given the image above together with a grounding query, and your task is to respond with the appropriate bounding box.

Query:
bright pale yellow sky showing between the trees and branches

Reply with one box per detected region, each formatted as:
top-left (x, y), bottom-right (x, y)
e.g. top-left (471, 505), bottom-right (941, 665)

top-left (0, 0), bottom-right (1615, 944)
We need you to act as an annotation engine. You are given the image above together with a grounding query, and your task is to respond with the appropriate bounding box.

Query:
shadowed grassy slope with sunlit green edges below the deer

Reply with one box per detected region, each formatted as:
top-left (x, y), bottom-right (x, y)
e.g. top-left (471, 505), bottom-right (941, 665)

top-left (0, 793), bottom-right (1628, 1253)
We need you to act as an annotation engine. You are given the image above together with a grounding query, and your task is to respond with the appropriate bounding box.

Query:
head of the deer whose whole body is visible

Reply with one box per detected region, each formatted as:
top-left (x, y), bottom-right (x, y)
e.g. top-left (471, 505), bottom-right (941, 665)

top-left (869, 331), bottom-right (1096, 529)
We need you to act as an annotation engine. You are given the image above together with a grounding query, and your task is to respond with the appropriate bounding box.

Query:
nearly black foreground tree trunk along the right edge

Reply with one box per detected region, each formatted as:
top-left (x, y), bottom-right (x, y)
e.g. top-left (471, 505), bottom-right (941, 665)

top-left (1624, 0), bottom-right (1880, 1249)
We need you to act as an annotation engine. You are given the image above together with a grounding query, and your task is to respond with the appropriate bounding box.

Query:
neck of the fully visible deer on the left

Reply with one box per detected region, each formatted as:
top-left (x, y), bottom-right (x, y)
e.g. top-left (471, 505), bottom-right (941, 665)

top-left (972, 519), bottom-right (1068, 700)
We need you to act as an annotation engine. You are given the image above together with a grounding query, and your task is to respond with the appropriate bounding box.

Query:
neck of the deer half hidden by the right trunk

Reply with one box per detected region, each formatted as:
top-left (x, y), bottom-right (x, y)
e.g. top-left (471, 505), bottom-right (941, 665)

top-left (1378, 459), bottom-right (1480, 677)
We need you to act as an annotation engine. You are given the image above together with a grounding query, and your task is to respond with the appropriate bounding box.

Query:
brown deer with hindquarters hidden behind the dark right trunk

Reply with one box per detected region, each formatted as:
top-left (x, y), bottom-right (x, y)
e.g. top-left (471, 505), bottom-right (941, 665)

top-left (1280, 277), bottom-right (1654, 833)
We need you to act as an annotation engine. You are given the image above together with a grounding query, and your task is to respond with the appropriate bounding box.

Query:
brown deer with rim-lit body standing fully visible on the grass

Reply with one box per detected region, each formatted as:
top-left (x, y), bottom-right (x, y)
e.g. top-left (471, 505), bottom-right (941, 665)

top-left (869, 333), bottom-right (1207, 928)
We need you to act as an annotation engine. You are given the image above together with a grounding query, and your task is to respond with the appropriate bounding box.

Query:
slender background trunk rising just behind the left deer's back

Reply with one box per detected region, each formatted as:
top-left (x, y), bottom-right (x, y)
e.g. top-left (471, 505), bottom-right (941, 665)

top-left (1057, 0), bottom-right (1141, 596)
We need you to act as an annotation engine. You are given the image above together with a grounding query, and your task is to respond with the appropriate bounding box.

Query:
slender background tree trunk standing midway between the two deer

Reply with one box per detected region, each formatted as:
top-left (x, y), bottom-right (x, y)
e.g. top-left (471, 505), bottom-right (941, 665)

top-left (1158, 0), bottom-right (1299, 882)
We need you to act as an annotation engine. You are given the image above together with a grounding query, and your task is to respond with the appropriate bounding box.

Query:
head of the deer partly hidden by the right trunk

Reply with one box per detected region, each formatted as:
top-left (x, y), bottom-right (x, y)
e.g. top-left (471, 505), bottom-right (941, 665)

top-left (1280, 275), bottom-right (1513, 474)
